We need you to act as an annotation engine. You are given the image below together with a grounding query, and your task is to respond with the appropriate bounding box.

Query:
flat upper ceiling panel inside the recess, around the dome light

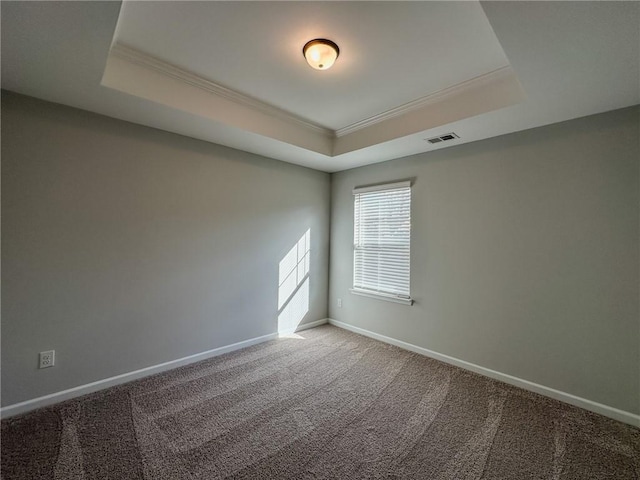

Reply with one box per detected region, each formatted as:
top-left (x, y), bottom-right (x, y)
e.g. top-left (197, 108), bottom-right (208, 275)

top-left (115, 1), bottom-right (509, 130)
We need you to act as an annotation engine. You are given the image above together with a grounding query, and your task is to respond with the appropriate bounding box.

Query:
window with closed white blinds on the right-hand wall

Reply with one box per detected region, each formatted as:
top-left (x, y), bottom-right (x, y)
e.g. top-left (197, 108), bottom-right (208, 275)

top-left (351, 182), bottom-right (413, 305)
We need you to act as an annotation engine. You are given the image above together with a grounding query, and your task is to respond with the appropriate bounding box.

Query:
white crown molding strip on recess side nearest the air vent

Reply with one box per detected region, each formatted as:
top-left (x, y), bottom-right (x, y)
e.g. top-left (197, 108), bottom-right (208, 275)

top-left (335, 65), bottom-right (514, 138)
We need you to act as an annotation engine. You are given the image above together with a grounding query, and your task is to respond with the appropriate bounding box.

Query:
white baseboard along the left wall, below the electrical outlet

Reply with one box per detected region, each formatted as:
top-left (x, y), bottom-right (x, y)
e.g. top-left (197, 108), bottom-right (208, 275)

top-left (0, 330), bottom-right (280, 418)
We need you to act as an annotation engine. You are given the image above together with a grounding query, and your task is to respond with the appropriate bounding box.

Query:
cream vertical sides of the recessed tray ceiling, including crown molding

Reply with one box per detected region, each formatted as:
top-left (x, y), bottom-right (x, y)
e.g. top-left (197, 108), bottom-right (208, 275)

top-left (102, 43), bottom-right (524, 157)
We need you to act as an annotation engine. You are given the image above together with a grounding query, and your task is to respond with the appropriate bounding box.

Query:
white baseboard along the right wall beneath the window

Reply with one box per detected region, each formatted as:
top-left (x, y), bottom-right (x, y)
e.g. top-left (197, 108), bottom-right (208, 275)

top-left (329, 318), bottom-right (640, 427)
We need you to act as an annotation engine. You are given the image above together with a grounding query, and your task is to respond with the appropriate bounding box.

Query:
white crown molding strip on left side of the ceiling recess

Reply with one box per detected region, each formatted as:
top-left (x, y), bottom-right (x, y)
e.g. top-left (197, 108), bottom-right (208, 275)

top-left (110, 43), bottom-right (335, 139)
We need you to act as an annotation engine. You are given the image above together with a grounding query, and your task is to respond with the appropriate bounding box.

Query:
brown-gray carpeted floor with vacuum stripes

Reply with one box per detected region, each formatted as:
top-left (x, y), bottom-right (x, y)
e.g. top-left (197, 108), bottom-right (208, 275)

top-left (2, 326), bottom-right (640, 480)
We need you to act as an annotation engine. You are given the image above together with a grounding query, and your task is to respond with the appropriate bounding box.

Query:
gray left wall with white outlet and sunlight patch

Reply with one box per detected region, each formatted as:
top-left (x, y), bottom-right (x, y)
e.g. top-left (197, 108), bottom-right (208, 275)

top-left (2, 92), bottom-right (330, 405)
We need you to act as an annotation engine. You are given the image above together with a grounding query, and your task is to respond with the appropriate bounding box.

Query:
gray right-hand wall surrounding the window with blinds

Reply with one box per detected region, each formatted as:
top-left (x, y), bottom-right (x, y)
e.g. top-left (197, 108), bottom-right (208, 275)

top-left (329, 107), bottom-right (640, 413)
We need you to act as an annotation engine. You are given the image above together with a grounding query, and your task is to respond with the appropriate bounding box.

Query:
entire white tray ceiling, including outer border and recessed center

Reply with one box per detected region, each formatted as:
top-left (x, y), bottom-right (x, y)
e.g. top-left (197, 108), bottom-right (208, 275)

top-left (0, 1), bottom-right (640, 171)
